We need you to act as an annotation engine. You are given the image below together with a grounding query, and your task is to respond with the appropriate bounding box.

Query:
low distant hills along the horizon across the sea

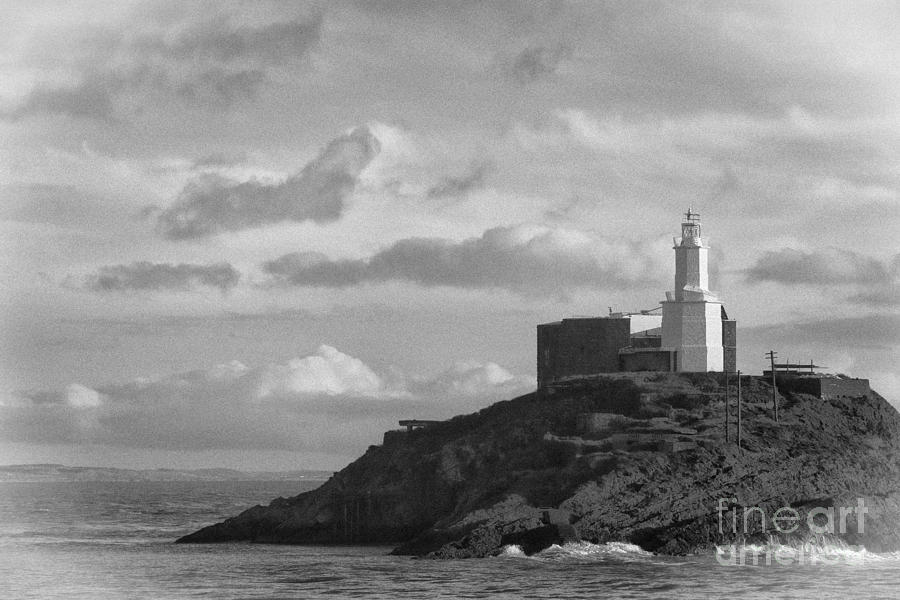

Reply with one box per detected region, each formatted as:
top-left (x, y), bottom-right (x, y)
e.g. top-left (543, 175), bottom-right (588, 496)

top-left (0, 464), bottom-right (331, 483)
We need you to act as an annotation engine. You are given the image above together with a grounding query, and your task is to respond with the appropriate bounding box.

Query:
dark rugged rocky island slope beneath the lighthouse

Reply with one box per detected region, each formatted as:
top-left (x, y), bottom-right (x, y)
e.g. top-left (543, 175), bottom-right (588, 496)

top-left (178, 374), bottom-right (900, 558)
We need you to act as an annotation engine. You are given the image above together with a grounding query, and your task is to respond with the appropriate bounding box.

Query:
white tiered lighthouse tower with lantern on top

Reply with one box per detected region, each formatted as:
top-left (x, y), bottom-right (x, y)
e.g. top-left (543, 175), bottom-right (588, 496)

top-left (661, 208), bottom-right (724, 372)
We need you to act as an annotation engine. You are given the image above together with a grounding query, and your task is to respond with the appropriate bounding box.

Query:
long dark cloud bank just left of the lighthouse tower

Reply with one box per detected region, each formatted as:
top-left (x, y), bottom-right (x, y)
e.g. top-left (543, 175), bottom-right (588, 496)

top-left (262, 225), bottom-right (652, 295)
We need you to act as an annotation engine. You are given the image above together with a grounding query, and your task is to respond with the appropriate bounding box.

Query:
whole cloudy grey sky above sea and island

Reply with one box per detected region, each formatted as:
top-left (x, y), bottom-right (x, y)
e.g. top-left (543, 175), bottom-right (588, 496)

top-left (0, 0), bottom-right (900, 469)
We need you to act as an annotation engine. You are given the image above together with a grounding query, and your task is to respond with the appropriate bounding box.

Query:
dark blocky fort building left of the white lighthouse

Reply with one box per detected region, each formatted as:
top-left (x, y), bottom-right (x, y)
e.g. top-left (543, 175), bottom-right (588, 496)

top-left (537, 318), bottom-right (631, 387)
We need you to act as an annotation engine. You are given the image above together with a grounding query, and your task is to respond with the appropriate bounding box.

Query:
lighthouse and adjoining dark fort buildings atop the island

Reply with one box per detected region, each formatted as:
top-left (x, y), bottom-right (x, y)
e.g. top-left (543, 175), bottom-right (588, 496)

top-left (537, 210), bottom-right (737, 387)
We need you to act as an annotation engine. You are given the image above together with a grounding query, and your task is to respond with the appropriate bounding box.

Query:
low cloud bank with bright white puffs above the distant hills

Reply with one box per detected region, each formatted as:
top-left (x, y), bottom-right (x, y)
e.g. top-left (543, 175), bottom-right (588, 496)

top-left (0, 345), bottom-right (534, 457)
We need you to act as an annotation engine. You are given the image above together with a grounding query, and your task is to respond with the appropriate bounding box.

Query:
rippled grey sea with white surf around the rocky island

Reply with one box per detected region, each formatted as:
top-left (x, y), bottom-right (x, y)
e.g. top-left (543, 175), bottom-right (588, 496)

top-left (0, 481), bottom-right (900, 600)
